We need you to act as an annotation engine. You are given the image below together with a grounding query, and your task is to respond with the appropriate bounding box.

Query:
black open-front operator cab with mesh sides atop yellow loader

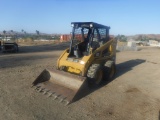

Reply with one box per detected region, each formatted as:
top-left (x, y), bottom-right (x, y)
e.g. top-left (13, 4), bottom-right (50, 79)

top-left (68, 22), bottom-right (110, 58)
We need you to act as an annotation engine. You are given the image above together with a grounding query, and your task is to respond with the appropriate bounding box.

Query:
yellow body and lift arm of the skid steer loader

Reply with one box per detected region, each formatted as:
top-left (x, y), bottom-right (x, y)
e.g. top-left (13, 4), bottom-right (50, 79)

top-left (57, 39), bottom-right (116, 76)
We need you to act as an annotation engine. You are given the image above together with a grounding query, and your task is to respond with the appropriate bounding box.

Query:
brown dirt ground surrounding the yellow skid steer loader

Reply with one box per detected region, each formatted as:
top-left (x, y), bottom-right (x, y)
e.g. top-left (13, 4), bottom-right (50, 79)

top-left (0, 43), bottom-right (160, 120)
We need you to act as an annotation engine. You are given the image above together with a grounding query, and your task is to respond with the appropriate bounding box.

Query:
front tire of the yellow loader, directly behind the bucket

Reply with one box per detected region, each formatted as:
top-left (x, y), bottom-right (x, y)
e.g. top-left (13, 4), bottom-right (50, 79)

top-left (87, 64), bottom-right (103, 87)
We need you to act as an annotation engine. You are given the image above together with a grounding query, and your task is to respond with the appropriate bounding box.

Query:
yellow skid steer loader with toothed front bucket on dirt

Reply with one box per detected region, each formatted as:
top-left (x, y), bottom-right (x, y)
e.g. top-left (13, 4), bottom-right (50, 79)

top-left (32, 22), bottom-right (117, 105)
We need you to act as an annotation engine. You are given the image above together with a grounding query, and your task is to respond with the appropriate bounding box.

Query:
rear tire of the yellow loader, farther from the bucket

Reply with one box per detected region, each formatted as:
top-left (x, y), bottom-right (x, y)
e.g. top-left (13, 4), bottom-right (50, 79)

top-left (103, 61), bottom-right (116, 81)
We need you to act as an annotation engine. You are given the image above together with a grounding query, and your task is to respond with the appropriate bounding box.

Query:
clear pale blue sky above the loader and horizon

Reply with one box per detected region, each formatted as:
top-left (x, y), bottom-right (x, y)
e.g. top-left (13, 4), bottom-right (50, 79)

top-left (0, 0), bottom-right (160, 35)
